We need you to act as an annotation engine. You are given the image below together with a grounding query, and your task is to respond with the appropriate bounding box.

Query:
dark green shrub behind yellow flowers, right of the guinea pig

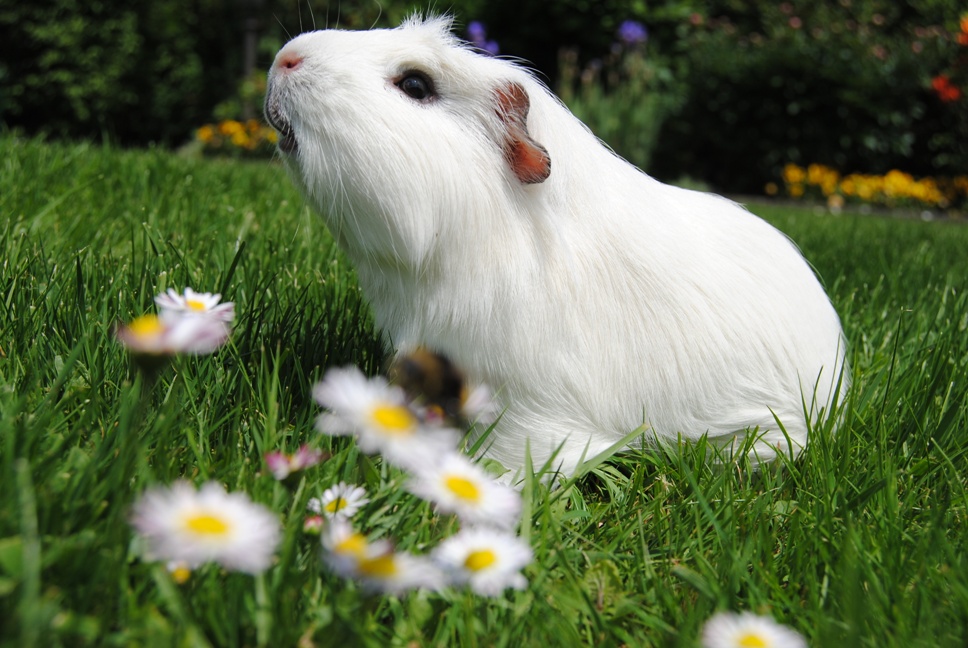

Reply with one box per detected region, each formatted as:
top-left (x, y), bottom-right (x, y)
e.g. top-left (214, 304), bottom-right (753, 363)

top-left (655, 0), bottom-right (968, 191)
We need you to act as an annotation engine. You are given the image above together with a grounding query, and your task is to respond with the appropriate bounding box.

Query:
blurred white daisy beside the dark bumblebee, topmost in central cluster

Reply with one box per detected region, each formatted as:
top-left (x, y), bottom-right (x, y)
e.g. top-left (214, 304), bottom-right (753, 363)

top-left (313, 367), bottom-right (459, 468)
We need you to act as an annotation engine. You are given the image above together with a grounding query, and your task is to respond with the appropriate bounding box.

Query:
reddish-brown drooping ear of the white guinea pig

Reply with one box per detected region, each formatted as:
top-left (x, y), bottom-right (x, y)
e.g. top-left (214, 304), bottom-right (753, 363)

top-left (495, 82), bottom-right (551, 184)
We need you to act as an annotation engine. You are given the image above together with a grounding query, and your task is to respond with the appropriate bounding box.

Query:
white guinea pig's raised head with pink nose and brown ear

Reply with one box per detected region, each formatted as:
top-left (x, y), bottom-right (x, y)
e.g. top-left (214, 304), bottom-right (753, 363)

top-left (265, 19), bottom-right (551, 268)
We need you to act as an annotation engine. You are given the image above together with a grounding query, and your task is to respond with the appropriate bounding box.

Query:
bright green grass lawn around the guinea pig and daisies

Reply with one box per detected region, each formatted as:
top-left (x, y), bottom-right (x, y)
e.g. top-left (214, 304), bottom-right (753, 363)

top-left (0, 136), bottom-right (968, 647)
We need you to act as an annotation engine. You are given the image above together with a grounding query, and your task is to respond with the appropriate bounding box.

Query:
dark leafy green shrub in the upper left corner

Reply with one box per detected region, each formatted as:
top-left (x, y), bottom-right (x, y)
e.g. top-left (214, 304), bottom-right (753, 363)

top-left (0, 0), bottom-right (240, 144)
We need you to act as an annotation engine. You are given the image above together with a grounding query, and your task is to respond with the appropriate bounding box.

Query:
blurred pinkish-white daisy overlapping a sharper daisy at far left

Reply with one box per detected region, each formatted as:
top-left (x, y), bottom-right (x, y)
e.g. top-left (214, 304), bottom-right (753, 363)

top-left (117, 315), bottom-right (231, 356)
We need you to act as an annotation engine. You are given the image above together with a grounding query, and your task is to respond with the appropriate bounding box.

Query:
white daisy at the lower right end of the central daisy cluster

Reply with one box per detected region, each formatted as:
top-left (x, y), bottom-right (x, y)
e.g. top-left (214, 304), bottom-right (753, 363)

top-left (433, 527), bottom-right (532, 596)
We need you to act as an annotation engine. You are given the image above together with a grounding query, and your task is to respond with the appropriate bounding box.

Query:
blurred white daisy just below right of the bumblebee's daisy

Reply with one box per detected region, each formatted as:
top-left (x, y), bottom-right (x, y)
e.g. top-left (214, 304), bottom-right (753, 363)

top-left (407, 452), bottom-right (521, 529)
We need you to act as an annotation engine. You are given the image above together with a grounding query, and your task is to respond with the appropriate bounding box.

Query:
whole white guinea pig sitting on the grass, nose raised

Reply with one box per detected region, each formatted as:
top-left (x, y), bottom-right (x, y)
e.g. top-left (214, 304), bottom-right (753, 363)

top-left (266, 18), bottom-right (849, 473)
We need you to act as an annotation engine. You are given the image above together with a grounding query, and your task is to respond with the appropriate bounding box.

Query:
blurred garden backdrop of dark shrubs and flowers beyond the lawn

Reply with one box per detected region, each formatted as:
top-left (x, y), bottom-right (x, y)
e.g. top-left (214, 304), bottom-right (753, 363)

top-left (0, 0), bottom-right (968, 205)
